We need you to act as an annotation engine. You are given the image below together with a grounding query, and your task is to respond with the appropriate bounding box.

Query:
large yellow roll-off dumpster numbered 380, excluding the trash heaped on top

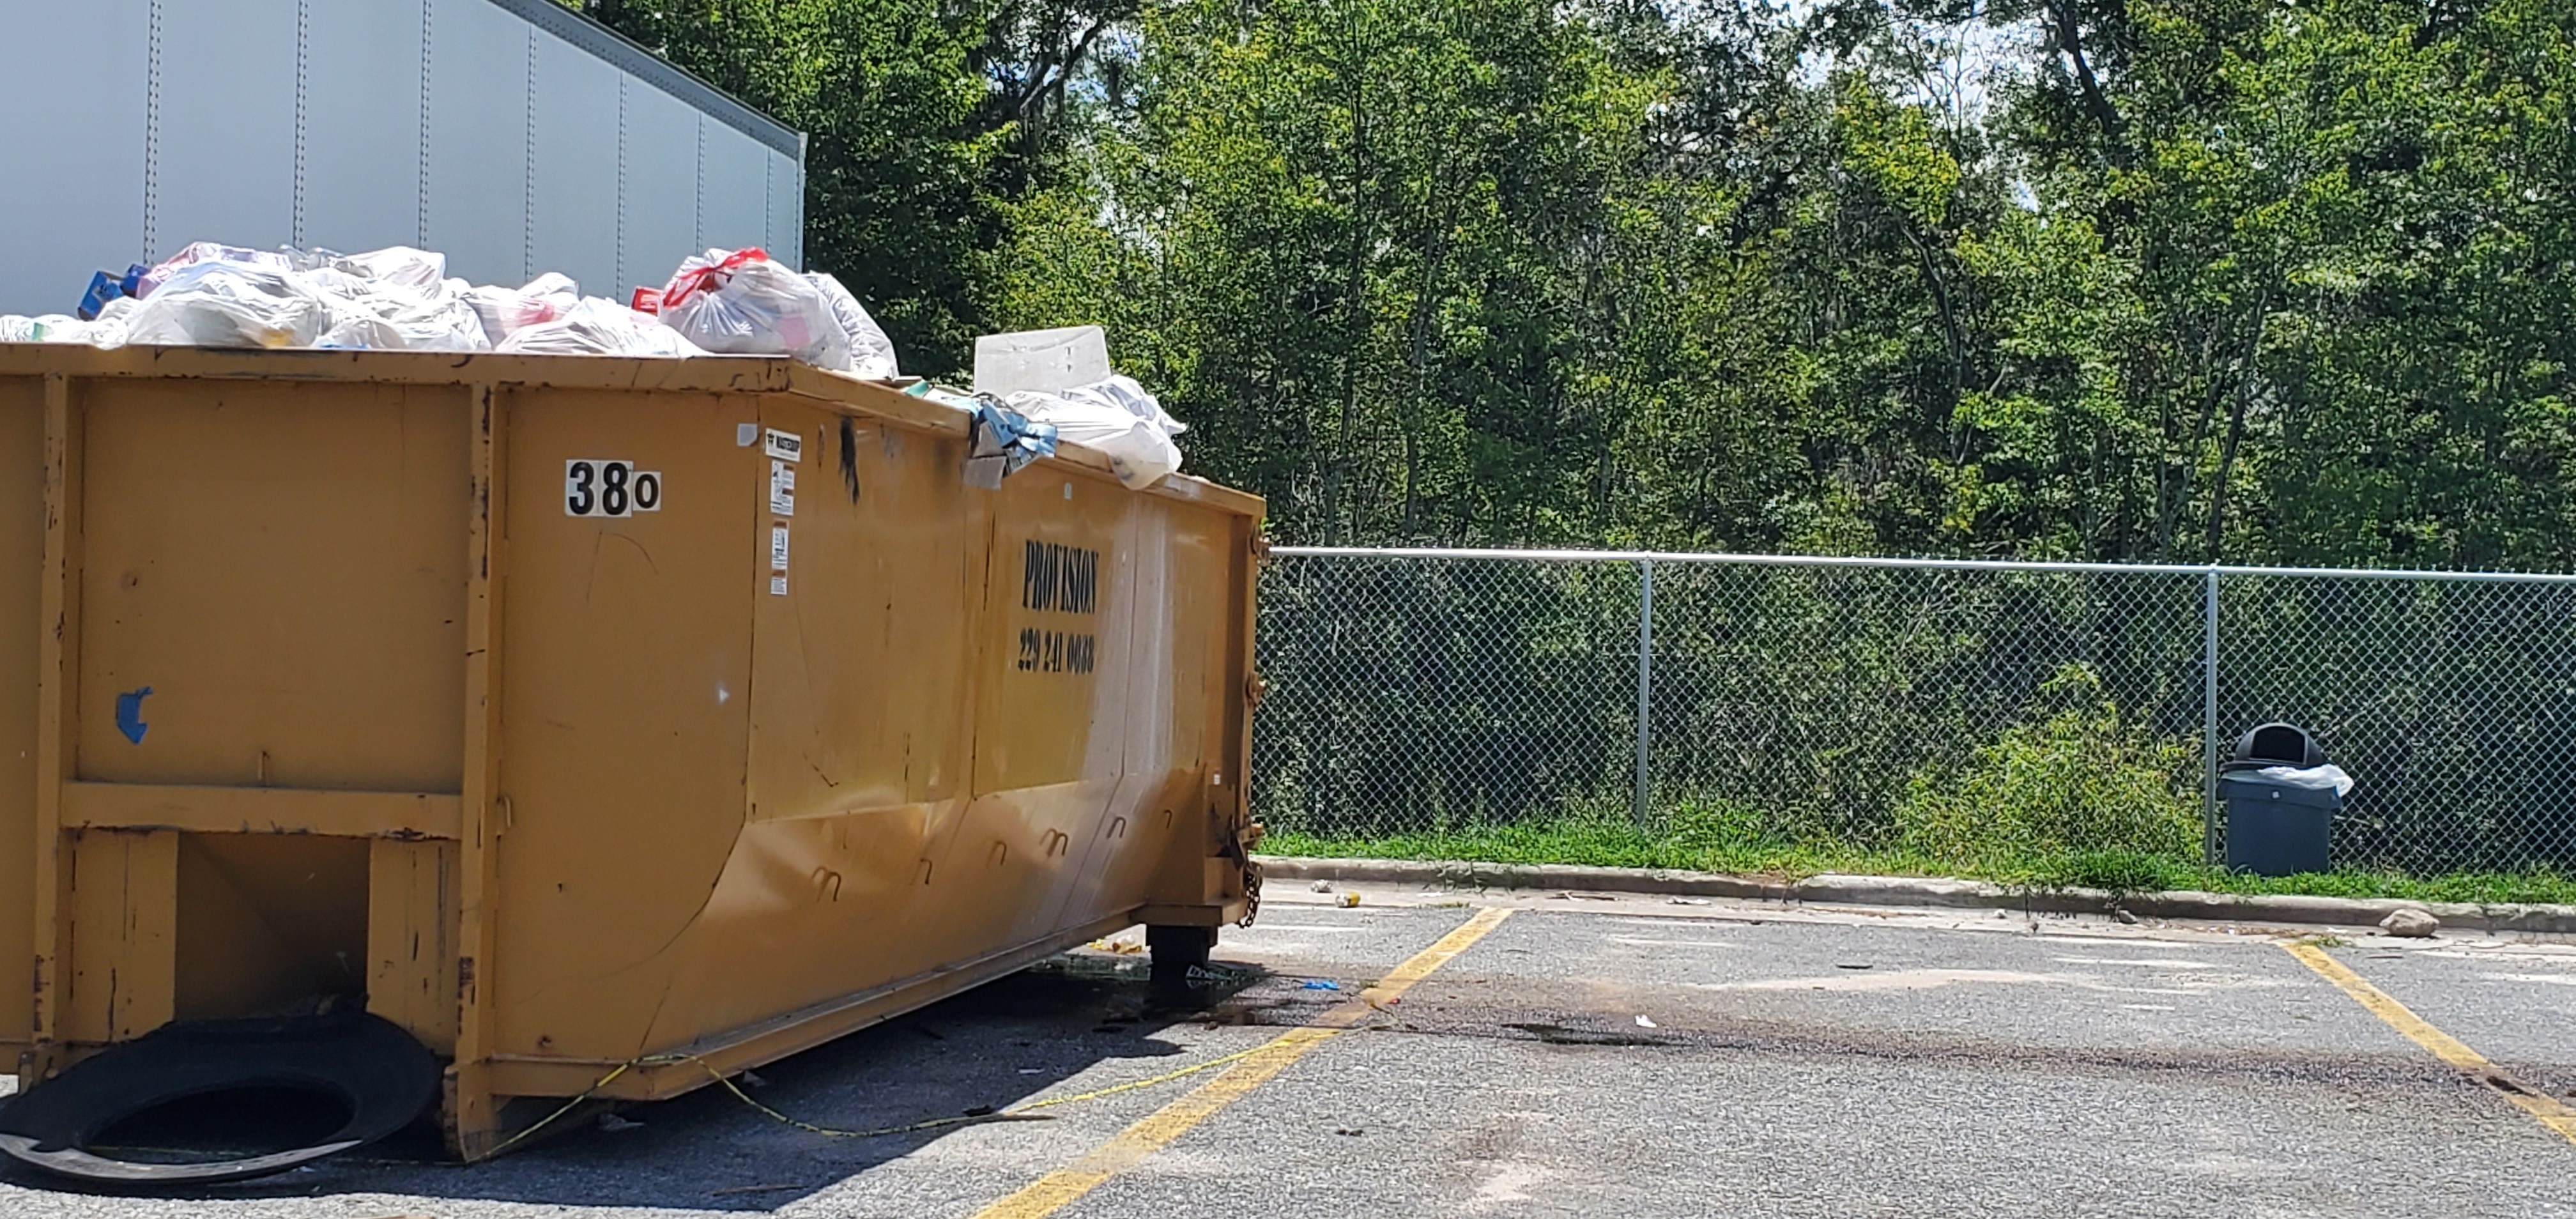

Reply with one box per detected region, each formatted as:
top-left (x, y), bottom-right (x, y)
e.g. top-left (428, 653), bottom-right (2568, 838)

top-left (0, 346), bottom-right (1262, 1160)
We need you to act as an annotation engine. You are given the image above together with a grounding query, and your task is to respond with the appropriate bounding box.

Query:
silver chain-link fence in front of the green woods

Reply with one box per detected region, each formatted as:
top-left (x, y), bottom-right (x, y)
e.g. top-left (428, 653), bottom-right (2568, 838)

top-left (1255, 546), bottom-right (2576, 873)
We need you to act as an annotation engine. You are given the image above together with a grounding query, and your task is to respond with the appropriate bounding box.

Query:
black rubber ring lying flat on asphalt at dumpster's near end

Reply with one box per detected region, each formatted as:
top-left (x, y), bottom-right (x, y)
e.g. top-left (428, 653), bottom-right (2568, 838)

top-left (0, 1010), bottom-right (438, 1186)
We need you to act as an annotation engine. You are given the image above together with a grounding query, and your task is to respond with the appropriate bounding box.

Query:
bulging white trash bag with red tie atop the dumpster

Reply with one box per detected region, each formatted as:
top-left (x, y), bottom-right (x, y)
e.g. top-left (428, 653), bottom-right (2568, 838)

top-left (636, 247), bottom-right (850, 371)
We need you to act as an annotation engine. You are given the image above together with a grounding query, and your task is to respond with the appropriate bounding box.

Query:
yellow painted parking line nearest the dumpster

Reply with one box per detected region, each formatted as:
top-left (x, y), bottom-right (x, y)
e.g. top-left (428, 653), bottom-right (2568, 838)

top-left (976, 907), bottom-right (1512, 1219)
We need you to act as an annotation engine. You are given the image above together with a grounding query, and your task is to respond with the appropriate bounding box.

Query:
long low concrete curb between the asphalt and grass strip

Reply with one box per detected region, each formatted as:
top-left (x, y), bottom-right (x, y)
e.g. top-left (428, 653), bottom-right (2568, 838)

top-left (1257, 855), bottom-right (2576, 935)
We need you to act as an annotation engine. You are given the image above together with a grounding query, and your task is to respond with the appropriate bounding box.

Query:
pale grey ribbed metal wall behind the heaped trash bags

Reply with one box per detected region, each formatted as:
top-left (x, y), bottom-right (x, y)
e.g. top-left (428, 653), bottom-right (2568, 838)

top-left (0, 0), bottom-right (804, 314)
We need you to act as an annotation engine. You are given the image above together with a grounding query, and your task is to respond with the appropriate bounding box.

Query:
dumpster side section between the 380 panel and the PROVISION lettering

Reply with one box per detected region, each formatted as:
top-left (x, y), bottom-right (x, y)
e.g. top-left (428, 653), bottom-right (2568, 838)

top-left (618, 397), bottom-right (989, 1049)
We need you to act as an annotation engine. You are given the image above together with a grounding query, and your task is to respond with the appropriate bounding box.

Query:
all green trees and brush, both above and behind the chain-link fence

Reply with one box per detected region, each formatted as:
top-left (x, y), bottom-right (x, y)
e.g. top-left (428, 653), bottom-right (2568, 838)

top-left (567, 0), bottom-right (2576, 892)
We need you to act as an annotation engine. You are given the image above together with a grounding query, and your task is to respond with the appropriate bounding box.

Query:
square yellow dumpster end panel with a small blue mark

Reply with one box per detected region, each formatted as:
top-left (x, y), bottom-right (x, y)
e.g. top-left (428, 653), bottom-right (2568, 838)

top-left (77, 379), bottom-right (466, 793)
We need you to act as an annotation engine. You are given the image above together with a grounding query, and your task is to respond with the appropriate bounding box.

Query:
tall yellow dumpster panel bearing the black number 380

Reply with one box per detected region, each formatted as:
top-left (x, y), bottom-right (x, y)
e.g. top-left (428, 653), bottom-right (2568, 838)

top-left (482, 389), bottom-right (768, 1062)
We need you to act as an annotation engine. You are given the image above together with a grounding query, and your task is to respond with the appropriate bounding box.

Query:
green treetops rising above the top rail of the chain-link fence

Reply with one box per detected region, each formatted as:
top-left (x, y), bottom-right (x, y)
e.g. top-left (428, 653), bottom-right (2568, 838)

top-left (587, 0), bottom-right (2576, 567)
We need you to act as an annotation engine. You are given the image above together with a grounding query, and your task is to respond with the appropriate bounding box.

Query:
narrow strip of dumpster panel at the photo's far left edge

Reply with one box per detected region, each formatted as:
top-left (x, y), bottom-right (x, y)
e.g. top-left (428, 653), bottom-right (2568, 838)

top-left (0, 376), bottom-right (44, 1044)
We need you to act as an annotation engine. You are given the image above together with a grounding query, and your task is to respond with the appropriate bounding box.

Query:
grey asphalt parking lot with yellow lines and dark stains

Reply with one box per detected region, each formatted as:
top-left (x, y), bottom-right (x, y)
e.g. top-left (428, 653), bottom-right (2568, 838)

top-left (0, 887), bottom-right (2576, 1219)
